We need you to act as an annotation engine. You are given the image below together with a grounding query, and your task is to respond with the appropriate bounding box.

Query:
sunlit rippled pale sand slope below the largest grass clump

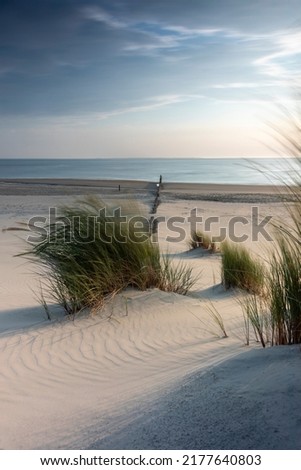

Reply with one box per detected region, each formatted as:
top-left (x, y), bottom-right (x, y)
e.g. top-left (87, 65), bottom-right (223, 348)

top-left (0, 284), bottom-right (242, 448)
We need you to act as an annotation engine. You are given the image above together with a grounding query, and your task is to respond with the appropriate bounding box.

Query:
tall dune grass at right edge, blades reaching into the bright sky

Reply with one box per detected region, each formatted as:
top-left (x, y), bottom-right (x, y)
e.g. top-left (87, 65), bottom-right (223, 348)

top-left (262, 95), bottom-right (301, 344)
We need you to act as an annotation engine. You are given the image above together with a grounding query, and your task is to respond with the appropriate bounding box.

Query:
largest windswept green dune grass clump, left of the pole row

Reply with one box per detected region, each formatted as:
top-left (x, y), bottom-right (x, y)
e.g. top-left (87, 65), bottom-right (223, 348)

top-left (22, 197), bottom-right (195, 314)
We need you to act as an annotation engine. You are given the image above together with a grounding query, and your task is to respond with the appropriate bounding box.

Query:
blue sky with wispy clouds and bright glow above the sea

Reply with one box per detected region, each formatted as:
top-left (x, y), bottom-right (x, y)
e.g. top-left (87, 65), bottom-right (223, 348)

top-left (0, 0), bottom-right (301, 158)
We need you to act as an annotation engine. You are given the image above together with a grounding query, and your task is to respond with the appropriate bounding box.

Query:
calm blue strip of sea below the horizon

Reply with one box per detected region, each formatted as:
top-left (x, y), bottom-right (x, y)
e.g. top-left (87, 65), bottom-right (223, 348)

top-left (0, 158), bottom-right (296, 184)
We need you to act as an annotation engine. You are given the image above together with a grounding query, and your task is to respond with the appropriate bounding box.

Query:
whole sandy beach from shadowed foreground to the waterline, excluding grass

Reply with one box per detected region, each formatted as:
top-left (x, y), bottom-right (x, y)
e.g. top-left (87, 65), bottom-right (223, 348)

top-left (0, 179), bottom-right (301, 449)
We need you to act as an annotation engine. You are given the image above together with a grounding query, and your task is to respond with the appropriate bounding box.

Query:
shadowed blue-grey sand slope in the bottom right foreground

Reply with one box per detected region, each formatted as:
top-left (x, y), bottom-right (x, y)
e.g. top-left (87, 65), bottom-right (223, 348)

top-left (91, 346), bottom-right (301, 450)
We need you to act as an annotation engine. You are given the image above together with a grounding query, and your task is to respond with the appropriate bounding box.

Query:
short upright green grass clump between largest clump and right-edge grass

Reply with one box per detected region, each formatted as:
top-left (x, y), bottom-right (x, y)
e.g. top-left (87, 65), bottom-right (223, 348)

top-left (221, 241), bottom-right (264, 294)
